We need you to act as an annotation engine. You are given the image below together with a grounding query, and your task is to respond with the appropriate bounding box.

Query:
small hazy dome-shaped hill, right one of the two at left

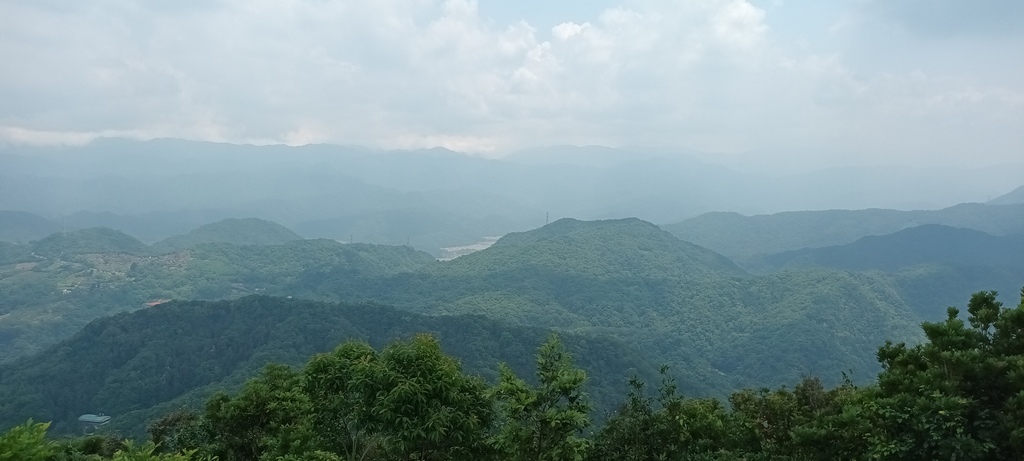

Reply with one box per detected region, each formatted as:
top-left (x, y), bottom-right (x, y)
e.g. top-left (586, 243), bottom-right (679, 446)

top-left (153, 218), bottom-right (302, 252)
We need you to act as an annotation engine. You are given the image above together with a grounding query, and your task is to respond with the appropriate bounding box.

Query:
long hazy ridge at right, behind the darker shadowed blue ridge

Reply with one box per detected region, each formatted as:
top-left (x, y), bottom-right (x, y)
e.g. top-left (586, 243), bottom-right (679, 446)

top-left (662, 204), bottom-right (1024, 261)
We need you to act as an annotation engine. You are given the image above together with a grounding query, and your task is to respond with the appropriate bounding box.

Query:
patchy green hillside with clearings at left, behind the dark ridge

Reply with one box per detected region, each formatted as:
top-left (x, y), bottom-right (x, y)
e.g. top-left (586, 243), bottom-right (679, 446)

top-left (0, 237), bottom-right (434, 363)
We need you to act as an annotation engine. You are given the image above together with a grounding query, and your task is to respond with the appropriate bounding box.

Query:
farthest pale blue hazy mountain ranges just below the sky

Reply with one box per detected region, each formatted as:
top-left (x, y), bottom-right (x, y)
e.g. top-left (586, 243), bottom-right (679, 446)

top-left (0, 139), bottom-right (1024, 254)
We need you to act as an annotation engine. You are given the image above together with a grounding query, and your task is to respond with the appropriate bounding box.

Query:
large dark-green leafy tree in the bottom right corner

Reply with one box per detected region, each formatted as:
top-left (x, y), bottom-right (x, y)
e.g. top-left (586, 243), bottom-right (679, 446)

top-left (847, 290), bottom-right (1024, 460)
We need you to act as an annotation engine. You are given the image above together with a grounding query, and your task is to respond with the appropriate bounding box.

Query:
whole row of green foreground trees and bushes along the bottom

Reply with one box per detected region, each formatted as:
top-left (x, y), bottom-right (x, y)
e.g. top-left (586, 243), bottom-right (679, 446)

top-left (8, 290), bottom-right (1024, 461)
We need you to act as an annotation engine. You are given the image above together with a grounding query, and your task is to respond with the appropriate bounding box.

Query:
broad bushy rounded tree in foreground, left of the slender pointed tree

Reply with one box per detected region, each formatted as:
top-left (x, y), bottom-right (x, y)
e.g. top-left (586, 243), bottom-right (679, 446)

top-left (305, 335), bottom-right (493, 460)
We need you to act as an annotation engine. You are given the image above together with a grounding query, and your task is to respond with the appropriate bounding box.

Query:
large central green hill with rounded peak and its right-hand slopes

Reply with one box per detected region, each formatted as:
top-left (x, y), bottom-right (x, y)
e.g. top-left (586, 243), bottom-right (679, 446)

top-left (297, 219), bottom-right (920, 394)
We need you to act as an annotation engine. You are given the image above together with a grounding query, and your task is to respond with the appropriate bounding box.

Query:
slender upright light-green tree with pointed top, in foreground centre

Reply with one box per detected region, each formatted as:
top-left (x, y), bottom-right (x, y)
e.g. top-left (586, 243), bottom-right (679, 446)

top-left (493, 335), bottom-right (591, 461)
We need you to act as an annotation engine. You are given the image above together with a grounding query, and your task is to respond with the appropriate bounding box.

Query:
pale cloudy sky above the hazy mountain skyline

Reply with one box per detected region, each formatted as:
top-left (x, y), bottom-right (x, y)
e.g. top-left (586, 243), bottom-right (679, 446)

top-left (0, 0), bottom-right (1024, 165)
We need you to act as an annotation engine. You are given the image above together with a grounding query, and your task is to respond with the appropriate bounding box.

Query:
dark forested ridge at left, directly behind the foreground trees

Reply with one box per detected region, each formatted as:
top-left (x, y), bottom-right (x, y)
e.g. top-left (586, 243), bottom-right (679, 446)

top-left (0, 297), bottom-right (655, 435)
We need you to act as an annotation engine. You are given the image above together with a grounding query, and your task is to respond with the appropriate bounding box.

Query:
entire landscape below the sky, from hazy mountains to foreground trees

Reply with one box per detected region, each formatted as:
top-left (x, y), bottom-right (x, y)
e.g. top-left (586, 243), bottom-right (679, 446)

top-left (0, 139), bottom-right (1024, 461)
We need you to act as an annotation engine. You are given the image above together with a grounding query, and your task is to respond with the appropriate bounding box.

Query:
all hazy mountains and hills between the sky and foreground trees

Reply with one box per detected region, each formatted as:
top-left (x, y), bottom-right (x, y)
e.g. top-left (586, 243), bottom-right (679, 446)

top-left (0, 139), bottom-right (1024, 444)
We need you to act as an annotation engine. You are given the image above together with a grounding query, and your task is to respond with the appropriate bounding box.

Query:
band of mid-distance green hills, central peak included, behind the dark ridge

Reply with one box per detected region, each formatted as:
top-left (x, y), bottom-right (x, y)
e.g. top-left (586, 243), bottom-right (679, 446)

top-left (0, 219), bottom-right (919, 394)
